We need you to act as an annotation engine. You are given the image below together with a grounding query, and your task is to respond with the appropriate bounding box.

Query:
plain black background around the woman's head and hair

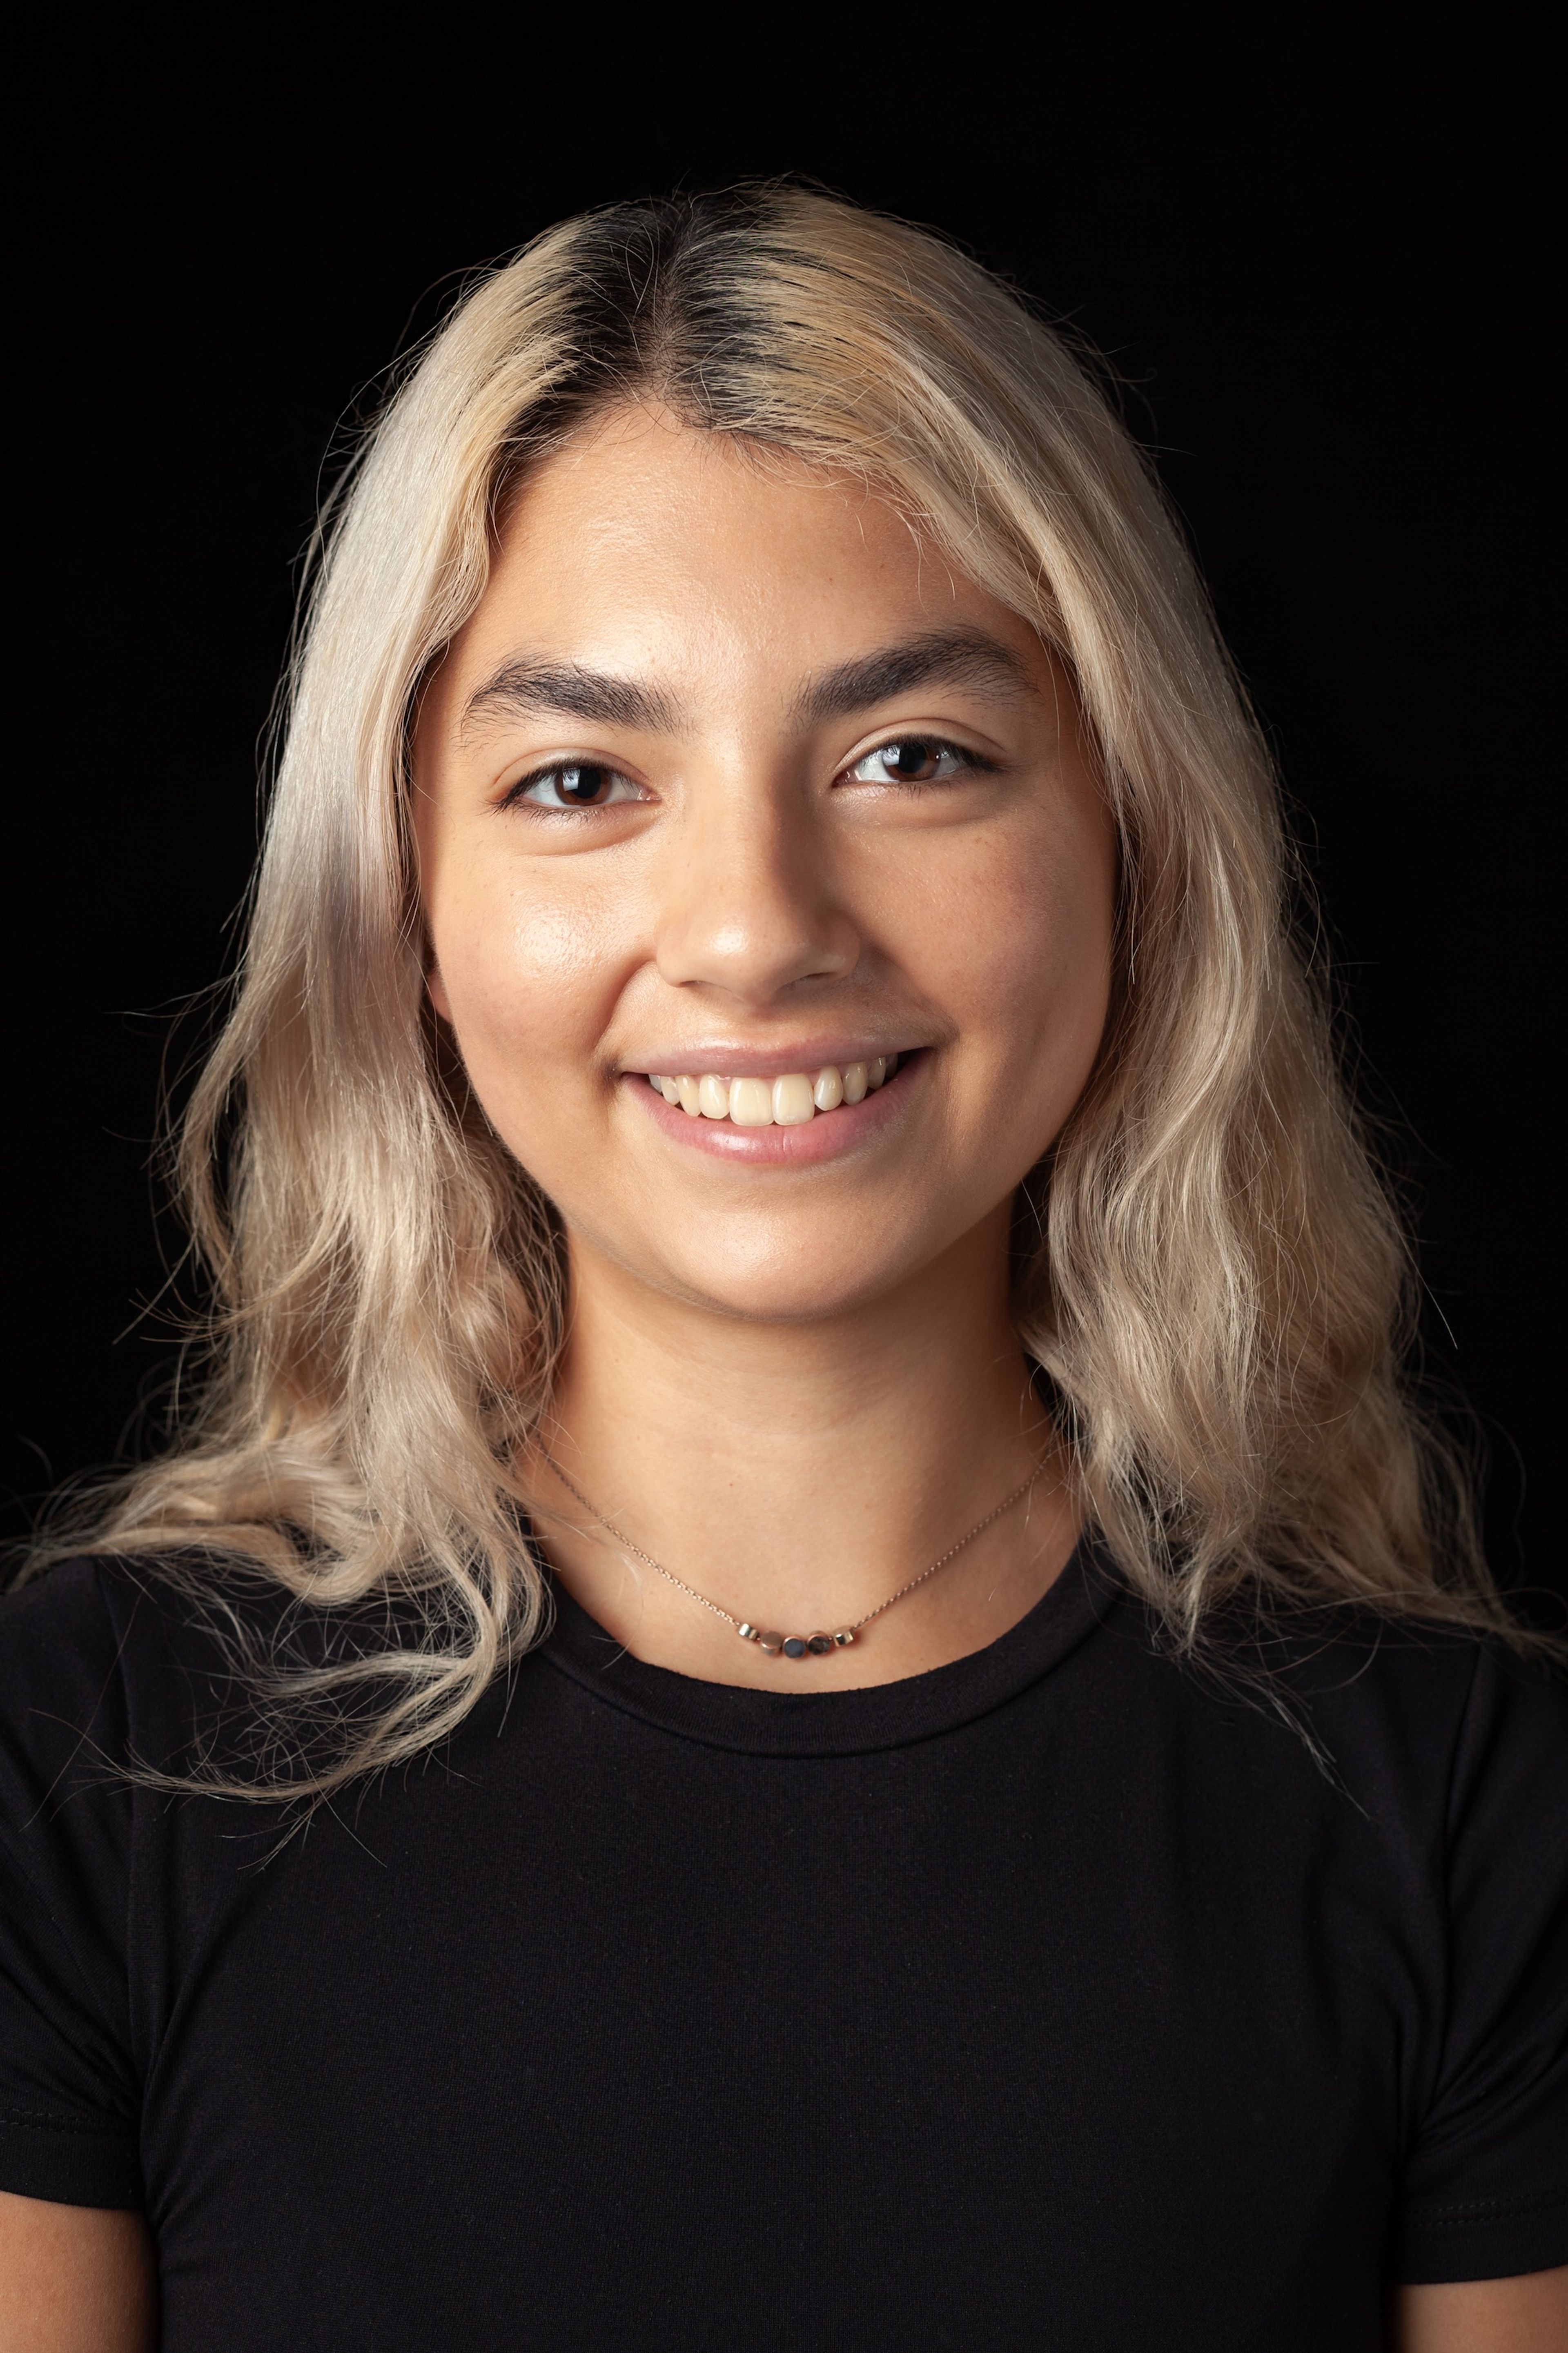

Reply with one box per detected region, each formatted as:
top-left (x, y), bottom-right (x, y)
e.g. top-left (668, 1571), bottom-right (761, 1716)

top-left (0, 9), bottom-right (1566, 1591)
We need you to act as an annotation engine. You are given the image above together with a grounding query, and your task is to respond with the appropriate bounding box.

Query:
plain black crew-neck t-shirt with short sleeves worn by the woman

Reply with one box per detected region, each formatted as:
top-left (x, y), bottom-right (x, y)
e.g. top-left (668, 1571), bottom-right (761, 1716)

top-left (0, 1548), bottom-right (1568, 2353)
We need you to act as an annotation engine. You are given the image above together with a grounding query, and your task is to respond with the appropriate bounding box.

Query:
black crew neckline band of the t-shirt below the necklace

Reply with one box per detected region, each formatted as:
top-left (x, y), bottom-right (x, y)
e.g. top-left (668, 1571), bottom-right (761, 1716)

top-left (537, 1534), bottom-right (1123, 1758)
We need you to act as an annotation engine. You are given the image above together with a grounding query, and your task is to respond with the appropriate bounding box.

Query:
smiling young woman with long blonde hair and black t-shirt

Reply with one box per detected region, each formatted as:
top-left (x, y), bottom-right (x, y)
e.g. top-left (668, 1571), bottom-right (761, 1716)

top-left (0, 188), bottom-right (1568, 2353)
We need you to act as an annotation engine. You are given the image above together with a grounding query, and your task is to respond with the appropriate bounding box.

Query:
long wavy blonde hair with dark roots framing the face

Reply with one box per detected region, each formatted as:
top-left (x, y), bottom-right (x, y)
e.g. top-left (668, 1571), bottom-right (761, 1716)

top-left (36, 186), bottom-right (1507, 1795)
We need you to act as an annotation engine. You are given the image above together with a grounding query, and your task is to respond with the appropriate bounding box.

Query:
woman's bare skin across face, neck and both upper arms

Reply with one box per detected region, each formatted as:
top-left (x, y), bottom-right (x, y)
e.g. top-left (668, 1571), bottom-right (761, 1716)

top-left (0, 412), bottom-right (1568, 2353)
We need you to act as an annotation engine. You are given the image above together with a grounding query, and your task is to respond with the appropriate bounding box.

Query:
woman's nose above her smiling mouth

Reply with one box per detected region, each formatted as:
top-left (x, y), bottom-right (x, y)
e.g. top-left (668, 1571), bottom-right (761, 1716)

top-left (657, 779), bottom-right (862, 1007)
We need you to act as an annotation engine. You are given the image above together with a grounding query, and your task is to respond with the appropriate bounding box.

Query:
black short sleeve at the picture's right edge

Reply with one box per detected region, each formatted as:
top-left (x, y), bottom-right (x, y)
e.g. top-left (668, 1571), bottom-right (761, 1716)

top-left (1392, 1650), bottom-right (1568, 2285)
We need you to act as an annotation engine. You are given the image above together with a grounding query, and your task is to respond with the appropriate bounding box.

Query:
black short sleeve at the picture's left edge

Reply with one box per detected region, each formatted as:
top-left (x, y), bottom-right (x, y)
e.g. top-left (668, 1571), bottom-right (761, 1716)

top-left (0, 1563), bottom-right (141, 2207)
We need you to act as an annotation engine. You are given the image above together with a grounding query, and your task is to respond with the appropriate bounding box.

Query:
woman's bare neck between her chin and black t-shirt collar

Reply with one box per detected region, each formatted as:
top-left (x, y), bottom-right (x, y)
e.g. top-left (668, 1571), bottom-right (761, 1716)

top-left (532, 1216), bottom-right (1076, 1690)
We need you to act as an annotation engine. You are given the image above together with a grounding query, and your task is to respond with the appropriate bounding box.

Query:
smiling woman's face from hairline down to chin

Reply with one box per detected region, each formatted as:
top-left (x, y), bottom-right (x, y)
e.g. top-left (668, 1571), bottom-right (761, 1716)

top-left (414, 410), bottom-right (1116, 1320)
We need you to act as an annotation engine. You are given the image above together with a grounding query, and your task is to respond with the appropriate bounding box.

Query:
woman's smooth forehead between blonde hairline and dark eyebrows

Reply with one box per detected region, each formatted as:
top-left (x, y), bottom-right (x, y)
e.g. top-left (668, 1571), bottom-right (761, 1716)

top-left (447, 407), bottom-right (1043, 697)
